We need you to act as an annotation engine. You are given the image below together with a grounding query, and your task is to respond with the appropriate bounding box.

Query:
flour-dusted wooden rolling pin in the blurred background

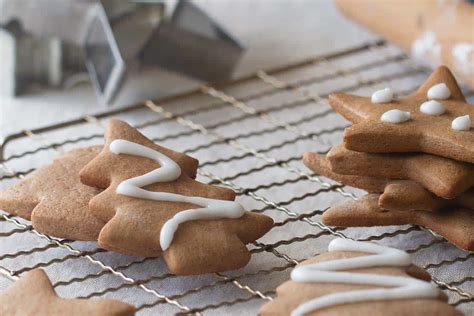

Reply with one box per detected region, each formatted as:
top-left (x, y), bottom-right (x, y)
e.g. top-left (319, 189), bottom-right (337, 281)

top-left (336, 0), bottom-right (474, 88)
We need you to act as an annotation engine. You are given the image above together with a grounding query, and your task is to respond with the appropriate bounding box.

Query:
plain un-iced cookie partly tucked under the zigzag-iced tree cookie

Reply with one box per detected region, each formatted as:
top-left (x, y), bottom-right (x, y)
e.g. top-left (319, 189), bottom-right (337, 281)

top-left (0, 146), bottom-right (104, 240)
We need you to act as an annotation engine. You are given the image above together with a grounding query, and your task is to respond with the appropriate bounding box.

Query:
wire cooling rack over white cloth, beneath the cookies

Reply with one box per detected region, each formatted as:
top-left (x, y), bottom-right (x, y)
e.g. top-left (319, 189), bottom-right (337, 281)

top-left (0, 40), bottom-right (474, 315)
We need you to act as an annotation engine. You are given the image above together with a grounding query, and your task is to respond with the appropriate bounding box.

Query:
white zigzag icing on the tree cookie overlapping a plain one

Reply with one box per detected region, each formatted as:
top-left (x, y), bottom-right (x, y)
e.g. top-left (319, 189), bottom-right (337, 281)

top-left (109, 139), bottom-right (245, 251)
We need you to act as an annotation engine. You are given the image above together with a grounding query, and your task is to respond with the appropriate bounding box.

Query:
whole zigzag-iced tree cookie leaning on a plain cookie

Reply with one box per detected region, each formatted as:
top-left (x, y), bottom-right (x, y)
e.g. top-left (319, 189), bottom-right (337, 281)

top-left (80, 120), bottom-right (273, 274)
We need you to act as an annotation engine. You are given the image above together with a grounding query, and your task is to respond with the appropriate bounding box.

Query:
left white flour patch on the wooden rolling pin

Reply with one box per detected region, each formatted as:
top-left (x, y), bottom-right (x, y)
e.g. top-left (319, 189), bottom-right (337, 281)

top-left (411, 31), bottom-right (441, 65)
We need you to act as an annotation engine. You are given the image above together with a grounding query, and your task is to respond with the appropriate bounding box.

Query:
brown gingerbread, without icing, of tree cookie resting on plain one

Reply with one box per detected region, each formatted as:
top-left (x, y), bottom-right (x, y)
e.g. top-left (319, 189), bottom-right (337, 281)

top-left (80, 120), bottom-right (273, 274)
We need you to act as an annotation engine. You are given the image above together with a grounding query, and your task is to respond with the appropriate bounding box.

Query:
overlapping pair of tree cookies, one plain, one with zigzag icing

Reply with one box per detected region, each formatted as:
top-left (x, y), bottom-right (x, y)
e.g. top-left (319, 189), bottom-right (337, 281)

top-left (0, 120), bottom-right (273, 275)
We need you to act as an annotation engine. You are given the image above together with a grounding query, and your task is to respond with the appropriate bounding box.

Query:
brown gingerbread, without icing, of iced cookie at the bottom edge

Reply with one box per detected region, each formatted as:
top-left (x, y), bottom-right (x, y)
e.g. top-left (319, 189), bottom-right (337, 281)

top-left (259, 241), bottom-right (462, 316)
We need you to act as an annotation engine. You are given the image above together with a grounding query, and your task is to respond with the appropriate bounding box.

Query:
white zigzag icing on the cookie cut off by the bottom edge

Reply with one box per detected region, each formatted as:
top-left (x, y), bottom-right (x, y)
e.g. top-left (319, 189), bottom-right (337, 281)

top-left (291, 238), bottom-right (439, 316)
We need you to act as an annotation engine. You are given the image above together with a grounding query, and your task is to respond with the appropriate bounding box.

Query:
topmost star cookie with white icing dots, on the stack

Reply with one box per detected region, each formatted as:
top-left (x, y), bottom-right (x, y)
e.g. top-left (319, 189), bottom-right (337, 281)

top-left (329, 66), bottom-right (474, 163)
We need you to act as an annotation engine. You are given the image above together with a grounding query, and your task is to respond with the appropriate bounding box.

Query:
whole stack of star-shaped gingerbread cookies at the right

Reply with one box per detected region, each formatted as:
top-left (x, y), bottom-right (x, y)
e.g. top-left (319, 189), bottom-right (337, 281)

top-left (304, 67), bottom-right (474, 251)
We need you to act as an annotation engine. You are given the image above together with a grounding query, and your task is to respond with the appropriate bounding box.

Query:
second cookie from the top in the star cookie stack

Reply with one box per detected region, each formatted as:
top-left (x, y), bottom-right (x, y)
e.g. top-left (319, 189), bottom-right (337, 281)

top-left (327, 145), bottom-right (474, 199)
